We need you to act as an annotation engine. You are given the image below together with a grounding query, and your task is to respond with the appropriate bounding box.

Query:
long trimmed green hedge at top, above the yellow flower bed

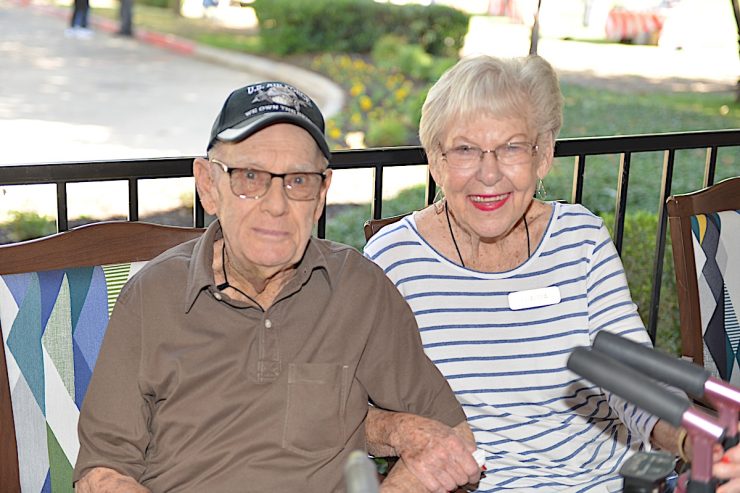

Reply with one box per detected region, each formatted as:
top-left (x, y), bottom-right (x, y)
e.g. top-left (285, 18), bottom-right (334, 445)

top-left (252, 0), bottom-right (469, 56)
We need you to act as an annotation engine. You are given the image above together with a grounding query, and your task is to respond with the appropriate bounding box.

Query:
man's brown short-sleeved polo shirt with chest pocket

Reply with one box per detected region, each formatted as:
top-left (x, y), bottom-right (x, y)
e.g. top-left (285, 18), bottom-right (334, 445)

top-left (74, 223), bottom-right (465, 493)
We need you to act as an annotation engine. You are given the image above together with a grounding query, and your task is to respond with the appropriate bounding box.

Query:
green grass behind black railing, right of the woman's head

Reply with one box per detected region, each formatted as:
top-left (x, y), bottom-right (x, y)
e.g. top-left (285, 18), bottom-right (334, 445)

top-left (545, 83), bottom-right (740, 212)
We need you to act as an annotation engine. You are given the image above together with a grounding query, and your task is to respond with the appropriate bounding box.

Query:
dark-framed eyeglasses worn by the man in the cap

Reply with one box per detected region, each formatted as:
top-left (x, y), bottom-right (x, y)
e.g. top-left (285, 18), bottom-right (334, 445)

top-left (209, 159), bottom-right (326, 200)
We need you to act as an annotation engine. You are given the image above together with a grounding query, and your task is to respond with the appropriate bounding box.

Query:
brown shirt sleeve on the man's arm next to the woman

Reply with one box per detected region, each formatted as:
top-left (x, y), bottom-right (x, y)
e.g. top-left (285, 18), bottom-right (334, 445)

top-left (358, 269), bottom-right (465, 426)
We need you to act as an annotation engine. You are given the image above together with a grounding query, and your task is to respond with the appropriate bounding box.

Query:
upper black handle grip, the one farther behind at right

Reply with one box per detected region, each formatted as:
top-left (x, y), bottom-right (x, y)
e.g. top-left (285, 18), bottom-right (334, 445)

top-left (593, 331), bottom-right (710, 398)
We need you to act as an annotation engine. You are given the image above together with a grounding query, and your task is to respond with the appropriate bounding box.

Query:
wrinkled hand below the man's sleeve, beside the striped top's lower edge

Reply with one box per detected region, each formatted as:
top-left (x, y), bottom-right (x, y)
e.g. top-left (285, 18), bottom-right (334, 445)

top-left (391, 414), bottom-right (481, 493)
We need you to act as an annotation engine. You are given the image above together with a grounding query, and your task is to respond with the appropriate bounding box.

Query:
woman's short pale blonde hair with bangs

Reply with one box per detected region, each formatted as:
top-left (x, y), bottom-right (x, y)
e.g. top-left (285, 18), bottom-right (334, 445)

top-left (419, 55), bottom-right (563, 159)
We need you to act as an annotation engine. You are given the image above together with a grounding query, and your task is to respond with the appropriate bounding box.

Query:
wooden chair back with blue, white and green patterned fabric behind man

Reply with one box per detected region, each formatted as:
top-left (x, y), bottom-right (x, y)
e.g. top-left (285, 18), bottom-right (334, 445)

top-left (0, 221), bottom-right (204, 492)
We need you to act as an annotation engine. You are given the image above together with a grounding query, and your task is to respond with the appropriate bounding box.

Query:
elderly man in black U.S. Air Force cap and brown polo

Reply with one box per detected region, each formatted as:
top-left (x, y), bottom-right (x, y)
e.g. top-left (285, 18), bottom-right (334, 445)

top-left (74, 82), bottom-right (478, 493)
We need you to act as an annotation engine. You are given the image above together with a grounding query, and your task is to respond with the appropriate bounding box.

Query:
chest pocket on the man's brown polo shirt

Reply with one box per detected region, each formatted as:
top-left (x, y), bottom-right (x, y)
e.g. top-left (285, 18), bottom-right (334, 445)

top-left (283, 363), bottom-right (350, 456)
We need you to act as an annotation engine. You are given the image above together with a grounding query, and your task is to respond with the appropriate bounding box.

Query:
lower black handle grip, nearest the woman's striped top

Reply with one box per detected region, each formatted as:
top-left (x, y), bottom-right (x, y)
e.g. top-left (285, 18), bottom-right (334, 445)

top-left (568, 347), bottom-right (689, 427)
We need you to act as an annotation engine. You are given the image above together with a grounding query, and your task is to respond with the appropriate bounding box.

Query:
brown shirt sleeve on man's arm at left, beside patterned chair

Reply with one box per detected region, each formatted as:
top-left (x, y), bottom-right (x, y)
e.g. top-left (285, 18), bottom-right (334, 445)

top-left (73, 286), bottom-right (150, 481)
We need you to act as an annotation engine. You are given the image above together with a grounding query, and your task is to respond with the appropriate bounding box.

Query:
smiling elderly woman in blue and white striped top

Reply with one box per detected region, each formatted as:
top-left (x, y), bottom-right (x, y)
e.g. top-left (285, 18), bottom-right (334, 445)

top-left (365, 56), bottom-right (740, 492)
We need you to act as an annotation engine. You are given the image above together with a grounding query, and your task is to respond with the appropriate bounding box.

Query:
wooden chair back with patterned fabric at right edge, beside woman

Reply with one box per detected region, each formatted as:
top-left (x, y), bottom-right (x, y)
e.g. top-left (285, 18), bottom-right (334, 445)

top-left (667, 177), bottom-right (740, 384)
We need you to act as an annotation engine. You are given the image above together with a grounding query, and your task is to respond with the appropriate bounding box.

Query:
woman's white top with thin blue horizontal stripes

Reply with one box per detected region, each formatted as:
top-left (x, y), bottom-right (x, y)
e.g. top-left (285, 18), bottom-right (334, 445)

top-left (365, 203), bottom-right (657, 492)
